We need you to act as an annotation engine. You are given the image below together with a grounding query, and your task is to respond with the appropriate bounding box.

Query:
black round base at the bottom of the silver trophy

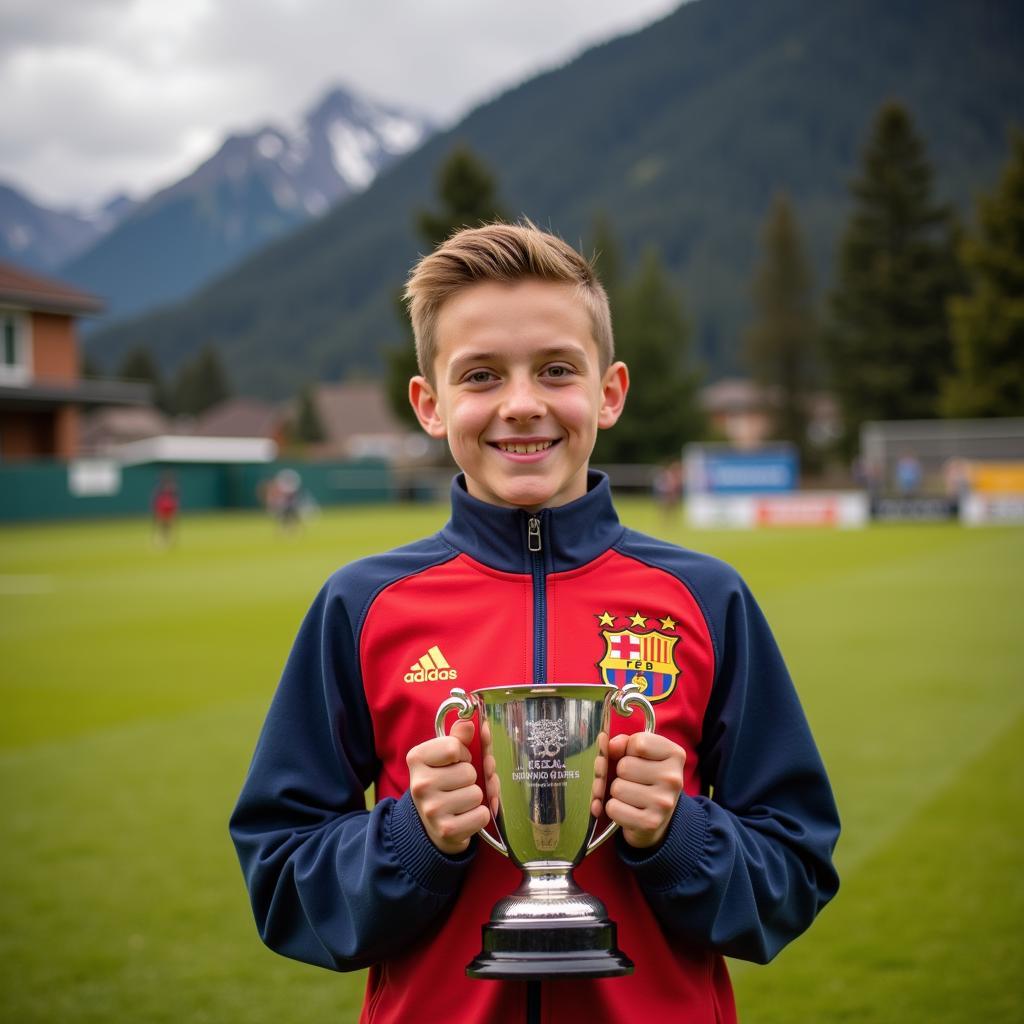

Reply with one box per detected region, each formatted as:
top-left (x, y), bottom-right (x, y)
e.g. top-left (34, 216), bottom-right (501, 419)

top-left (466, 921), bottom-right (633, 981)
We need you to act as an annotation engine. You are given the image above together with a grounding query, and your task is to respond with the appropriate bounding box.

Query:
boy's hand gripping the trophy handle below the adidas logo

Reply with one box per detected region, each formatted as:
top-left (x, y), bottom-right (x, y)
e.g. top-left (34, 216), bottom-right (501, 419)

top-left (406, 722), bottom-right (490, 854)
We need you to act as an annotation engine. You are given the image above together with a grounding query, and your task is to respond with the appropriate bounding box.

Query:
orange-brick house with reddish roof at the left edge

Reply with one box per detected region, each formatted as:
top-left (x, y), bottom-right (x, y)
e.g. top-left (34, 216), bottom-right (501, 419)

top-left (0, 263), bottom-right (150, 462)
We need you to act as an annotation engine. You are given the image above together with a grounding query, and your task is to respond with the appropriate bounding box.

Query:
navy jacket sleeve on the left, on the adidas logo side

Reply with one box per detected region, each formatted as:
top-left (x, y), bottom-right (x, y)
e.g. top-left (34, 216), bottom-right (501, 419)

top-left (230, 581), bottom-right (474, 971)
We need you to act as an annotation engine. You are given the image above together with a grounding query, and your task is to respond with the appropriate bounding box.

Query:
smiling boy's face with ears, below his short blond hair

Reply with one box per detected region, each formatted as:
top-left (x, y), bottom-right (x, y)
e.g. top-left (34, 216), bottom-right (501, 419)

top-left (410, 279), bottom-right (629, 510)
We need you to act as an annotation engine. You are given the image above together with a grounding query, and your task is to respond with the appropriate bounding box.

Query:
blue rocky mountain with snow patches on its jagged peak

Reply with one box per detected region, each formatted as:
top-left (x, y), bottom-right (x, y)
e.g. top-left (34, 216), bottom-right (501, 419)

top-left (62, 88), bottom-right (432, 327)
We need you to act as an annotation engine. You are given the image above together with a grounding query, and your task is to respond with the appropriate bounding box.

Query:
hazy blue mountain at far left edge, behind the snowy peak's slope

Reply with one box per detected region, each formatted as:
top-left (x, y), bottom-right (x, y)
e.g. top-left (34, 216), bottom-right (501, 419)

top-left (0, 183), bottom-right (135, 271)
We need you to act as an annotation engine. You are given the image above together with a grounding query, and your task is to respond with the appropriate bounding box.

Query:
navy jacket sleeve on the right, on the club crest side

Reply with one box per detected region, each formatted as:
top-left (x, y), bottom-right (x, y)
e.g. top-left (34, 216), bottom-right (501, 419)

top-left (618, 579), bottom-right (840, 964)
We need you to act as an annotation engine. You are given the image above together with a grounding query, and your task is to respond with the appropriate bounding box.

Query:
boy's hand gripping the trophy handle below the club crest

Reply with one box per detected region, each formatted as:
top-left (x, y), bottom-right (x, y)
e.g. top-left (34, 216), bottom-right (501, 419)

top-left (604, 732), bottom-right (686, 850)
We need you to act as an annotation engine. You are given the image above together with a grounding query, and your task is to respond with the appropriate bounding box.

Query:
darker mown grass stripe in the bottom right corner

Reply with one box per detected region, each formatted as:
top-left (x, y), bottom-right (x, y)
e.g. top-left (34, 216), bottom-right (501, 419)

top-left (735, 716), bottom-right (1024, 1024)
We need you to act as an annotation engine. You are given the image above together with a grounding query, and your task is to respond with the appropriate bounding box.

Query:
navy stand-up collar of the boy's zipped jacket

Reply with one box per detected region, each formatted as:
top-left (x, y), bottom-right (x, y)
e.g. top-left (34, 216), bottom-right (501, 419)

top-left (441, 470), bottom-right (624, 572)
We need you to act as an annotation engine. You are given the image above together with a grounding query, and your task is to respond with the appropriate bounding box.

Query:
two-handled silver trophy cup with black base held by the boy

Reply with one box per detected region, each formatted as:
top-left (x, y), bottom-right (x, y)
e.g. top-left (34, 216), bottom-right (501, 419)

top-left (435, 683), bottom-right (654, 979)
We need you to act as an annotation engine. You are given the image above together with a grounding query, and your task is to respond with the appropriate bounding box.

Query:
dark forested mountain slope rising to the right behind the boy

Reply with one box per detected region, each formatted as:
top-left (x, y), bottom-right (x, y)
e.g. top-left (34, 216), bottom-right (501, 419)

top-left (91, 0), bottom-right (1024, 395)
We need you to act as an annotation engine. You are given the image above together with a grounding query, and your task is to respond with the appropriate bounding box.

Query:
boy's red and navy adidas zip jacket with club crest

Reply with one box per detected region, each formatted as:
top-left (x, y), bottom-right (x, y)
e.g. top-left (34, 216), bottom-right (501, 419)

top-left (230, 473), bottom-right (839, 1024)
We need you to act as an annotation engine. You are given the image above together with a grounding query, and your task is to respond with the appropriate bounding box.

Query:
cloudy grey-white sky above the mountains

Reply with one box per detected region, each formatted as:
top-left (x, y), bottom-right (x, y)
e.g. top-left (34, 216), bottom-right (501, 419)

top-left (0, 0), bottom-right (679, 206)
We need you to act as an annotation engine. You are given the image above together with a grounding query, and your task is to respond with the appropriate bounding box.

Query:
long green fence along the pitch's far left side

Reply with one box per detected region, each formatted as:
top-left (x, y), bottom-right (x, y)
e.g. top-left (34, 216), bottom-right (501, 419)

top-left (0, 459), bottom-right (395, 522)
